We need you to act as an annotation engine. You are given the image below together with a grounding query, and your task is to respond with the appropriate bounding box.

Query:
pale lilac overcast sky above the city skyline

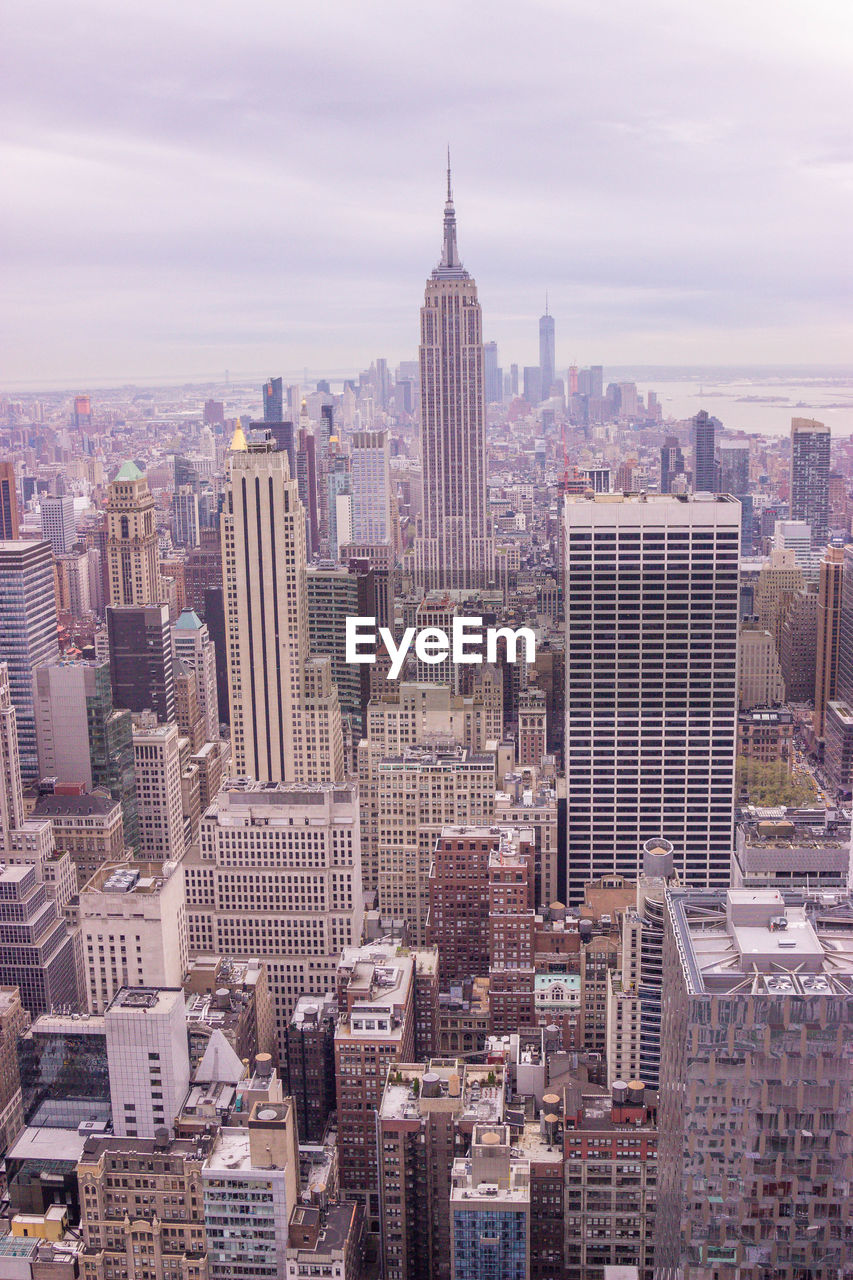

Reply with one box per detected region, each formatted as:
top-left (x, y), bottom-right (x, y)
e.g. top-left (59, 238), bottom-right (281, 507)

top-left (0, 0), bottom-right (853, 389)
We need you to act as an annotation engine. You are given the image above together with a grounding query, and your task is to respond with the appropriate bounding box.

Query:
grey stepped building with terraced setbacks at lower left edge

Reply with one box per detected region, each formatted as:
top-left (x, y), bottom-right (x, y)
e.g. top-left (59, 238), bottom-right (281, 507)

top-left (0, 865), bottom-right (79, 1018)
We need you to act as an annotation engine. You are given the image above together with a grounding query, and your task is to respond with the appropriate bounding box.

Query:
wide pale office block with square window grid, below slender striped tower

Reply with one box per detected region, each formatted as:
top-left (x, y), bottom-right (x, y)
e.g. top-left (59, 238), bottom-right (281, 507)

top-left (184, 783), bottom-right (362, 1056)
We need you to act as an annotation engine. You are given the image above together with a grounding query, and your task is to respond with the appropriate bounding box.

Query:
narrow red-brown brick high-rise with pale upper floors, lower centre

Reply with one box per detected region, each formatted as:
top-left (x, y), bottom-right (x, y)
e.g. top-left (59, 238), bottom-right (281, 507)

top-left (334, 942), bottom-right (415, 1230)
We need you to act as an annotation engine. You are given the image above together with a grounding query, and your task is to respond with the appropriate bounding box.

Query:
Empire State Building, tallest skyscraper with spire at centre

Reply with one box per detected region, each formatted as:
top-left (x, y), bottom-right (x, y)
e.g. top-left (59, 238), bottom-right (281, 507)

top-left (415, 165), bottom-right (494, 590)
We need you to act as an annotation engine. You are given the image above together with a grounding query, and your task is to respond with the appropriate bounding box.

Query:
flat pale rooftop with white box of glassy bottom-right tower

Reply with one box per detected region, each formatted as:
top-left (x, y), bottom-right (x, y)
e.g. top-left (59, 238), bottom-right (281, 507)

top-left (667, 888), bottom-right (853, 996)
